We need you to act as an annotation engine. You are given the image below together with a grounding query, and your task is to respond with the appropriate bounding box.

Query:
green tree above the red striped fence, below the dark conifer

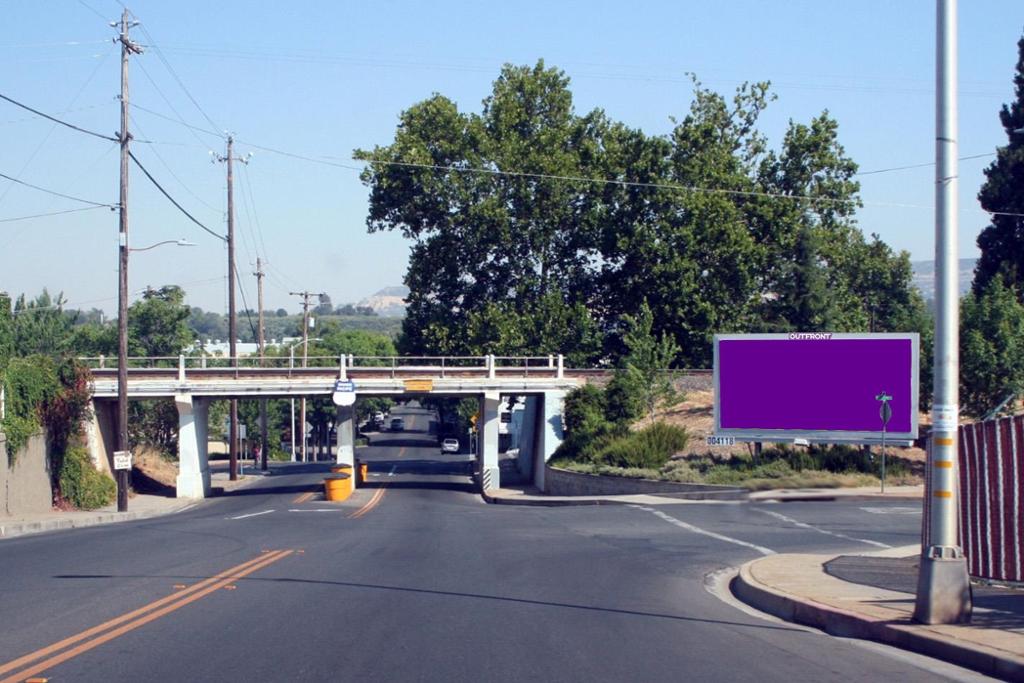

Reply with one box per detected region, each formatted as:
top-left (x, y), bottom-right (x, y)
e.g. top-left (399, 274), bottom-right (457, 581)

top-left (961, 278), bottom-right (1024, 417)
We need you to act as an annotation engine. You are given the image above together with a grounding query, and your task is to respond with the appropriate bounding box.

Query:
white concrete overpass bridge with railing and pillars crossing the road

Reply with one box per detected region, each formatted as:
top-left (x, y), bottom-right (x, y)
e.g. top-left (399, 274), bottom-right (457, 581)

top-left (83, 355), bottom-right (604, 499)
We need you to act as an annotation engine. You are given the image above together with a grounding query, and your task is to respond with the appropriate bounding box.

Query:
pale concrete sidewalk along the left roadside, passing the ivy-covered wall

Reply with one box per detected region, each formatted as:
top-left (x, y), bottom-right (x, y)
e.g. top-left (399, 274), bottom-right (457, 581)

top-left (0, 471), bottom-right (264, 540)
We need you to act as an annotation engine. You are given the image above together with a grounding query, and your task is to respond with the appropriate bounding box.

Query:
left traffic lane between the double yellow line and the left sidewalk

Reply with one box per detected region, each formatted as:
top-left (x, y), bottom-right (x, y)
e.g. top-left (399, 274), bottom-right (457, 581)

top-left (0, 465), bottom-right (385, 658)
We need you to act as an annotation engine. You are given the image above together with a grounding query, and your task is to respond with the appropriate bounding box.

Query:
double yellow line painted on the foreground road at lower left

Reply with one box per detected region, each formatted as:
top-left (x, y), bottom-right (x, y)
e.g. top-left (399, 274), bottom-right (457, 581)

top-left (0, 550), bottom-right (294, 683)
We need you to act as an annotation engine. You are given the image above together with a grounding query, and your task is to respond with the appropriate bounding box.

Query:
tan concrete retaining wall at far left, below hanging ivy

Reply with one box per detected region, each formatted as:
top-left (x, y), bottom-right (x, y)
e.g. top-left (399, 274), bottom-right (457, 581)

top-left (0, 433), bottom-right (53, 515)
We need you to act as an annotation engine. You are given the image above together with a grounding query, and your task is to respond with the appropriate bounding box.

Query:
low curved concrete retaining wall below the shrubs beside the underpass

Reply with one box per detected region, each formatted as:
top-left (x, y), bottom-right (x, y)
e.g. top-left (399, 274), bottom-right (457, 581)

top-left (544, 466), bottom-right (748, 500)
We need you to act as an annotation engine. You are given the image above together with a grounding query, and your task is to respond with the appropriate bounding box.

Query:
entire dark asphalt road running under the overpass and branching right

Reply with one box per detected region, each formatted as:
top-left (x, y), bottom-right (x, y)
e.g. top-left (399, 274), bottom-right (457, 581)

top-left (0, 411), bottom-right (991, 682)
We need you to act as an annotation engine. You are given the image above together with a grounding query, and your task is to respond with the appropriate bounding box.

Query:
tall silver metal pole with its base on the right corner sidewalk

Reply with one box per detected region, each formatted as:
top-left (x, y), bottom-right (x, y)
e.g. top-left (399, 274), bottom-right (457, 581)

top-left (913, 0), bottom-right (971, 624)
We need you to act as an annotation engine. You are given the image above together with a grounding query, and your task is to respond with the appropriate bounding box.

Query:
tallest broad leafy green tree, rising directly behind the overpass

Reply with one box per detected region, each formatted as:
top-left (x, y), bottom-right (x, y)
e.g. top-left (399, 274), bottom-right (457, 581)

top-left (356, 61), bottom-right (607, 360)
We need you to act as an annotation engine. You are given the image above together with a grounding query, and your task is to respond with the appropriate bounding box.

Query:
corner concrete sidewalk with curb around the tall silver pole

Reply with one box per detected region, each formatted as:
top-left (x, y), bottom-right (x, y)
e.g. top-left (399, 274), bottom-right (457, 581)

top-left (732, 546), bottom-right (1024, 681)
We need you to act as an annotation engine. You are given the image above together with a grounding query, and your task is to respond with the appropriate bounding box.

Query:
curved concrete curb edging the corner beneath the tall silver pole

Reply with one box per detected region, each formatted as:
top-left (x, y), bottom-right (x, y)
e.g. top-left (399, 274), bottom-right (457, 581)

top-left (729, 560), bottom-right (1024, 681)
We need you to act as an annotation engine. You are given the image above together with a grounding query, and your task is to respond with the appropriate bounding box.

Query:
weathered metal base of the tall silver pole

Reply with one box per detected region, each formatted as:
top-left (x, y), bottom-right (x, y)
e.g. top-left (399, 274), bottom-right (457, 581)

top-left (913, 546), bottom-right (972, 624)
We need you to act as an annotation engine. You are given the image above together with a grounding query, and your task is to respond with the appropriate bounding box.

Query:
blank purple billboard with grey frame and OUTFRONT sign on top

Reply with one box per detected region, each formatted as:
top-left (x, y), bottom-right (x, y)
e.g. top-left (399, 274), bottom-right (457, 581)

top-left (715, 332), bottom-right (919, 443)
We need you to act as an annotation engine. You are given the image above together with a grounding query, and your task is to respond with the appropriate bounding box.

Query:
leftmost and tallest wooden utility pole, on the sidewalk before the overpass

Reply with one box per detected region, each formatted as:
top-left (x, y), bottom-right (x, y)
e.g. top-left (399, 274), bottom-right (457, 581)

top-left (111, 8), bottom-right (142, 512)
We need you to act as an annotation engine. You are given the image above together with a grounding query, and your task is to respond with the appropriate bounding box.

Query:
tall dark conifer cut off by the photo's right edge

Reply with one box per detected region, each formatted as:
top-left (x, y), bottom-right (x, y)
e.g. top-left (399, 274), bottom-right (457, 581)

top-left (974, 33), bottom-right (1024, 297)
